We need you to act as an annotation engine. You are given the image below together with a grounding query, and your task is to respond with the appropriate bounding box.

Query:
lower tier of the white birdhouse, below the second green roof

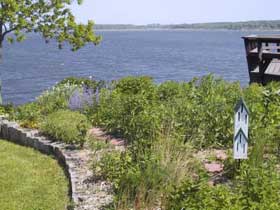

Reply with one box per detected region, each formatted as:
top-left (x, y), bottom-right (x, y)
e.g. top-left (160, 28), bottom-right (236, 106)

top-left (233, 129), bottom-right (248, 159)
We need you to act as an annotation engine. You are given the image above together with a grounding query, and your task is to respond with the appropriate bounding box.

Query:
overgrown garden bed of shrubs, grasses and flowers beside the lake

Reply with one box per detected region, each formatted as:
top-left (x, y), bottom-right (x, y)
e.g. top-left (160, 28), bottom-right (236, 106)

top-left (2, 75), bottom-right (280, 210)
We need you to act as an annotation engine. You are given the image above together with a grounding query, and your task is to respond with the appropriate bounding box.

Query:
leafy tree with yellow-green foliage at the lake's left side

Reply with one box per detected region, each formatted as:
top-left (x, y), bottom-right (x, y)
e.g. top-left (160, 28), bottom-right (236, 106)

top-left (0, 0), bottom-right (101, 103)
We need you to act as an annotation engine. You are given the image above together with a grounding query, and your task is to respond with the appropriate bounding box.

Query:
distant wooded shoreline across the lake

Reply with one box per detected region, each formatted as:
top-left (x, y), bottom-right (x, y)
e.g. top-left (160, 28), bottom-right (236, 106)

top-left (95, 20), bottom-right (280, 30)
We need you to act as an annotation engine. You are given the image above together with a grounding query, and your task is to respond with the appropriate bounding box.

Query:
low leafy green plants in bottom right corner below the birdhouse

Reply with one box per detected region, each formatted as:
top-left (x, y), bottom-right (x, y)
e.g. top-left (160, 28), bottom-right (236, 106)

top-left (167, 163), bottom-right (280, 210)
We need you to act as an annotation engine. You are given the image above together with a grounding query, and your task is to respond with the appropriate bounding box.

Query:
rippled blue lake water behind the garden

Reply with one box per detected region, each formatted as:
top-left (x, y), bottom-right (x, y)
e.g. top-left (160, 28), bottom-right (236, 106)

top-left (0, 30), bottom-right (276, 104)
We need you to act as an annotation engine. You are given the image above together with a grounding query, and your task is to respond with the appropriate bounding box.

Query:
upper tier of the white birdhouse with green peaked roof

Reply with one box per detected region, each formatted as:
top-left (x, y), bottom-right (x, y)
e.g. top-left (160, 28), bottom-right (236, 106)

top-left (234, 99), bottom-right (249, 139)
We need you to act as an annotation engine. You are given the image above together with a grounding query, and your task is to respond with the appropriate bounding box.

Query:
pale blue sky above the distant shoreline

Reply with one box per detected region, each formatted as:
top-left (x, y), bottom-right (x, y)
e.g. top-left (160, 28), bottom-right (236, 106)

top-left (72, 0), bottom-right (280, 24)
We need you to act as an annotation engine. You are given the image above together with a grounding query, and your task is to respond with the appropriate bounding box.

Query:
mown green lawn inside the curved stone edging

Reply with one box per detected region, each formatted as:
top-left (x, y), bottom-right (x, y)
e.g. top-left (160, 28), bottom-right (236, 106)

top-left (0, 140), bottom-right (69, 210)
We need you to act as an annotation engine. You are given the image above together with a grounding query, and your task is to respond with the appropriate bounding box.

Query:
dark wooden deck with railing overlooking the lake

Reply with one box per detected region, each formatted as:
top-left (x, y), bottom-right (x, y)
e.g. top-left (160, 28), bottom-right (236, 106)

top-left (243, 35), bottom-right (280, 84)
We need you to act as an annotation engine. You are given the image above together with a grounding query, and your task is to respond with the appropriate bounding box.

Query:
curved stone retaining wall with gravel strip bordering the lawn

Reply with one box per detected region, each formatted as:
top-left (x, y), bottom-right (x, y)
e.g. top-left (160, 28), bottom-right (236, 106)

top-left (0, 119), bottom-right (113, 210)
